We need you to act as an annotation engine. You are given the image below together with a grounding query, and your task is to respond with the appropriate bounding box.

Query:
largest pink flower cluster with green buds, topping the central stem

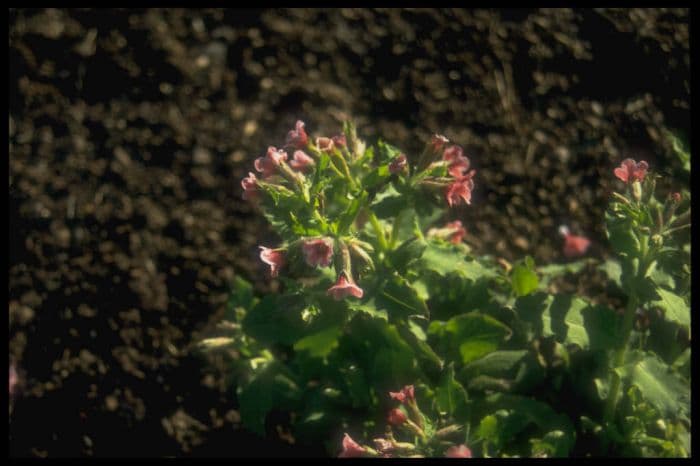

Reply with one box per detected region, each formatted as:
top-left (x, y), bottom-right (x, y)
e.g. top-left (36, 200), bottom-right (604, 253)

top-left (241, 121), bottom-right (476, 300)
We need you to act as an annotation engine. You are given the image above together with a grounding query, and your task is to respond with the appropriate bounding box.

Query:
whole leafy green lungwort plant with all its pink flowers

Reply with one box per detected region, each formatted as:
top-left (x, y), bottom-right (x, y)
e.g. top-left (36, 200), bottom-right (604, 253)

top-left (202, 122), bottom-right (690, 457)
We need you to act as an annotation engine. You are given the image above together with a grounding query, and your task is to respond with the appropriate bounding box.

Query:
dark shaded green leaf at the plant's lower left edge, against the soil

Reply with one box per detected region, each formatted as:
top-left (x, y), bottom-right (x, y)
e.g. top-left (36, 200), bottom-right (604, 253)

top-left (238, 361), bottom-right (301, 435)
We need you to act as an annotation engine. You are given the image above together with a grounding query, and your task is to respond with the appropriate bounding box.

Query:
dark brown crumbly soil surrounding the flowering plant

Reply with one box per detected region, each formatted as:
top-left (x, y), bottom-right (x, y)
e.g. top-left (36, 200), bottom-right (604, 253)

top-left (9, 9), bottom-right (690, 457)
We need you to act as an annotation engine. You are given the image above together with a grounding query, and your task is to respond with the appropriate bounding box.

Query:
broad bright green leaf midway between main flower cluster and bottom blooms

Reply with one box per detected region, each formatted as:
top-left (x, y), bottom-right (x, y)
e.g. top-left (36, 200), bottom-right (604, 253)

top-left (428, 312), bottom-right (511, 364)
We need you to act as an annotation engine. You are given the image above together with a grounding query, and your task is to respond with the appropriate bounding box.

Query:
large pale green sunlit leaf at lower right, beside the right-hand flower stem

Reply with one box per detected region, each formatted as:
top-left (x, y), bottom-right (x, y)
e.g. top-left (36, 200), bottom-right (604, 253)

top-left (615, 354), bottom-right (690, 418)
